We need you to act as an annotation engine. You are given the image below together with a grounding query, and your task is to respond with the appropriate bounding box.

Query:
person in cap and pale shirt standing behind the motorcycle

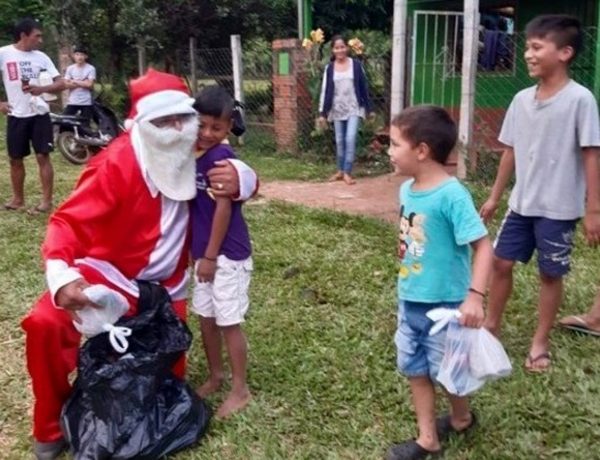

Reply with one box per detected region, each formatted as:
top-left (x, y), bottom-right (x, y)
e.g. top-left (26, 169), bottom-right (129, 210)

top-left (63, 46), bottom-right (96, 122)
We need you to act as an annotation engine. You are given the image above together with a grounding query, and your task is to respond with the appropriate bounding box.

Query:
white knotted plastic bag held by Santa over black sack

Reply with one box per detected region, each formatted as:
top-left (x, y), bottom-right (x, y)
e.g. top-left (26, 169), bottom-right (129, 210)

top-left (73, 284), bottom-right (131, 353)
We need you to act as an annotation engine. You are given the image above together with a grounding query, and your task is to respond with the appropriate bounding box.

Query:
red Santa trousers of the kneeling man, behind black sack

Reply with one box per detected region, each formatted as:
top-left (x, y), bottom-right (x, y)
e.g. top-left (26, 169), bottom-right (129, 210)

top-left (21, 266), bottom-right (186, 442)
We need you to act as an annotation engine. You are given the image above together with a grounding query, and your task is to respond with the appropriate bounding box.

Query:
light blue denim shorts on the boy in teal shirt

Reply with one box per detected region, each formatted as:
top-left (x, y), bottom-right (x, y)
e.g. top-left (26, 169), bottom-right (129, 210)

top-left (394, 300), bottom-right (461, 383)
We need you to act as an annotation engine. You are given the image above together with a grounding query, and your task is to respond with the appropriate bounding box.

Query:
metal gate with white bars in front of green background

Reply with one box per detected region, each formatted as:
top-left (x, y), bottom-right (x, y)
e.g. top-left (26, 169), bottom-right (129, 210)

top-left (410, 10), bottom-right (463, 120)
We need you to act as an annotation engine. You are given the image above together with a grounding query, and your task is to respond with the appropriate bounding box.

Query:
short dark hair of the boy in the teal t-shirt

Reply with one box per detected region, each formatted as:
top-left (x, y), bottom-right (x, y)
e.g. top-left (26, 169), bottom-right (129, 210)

top-left (392, 105), bottom-right (458, 164)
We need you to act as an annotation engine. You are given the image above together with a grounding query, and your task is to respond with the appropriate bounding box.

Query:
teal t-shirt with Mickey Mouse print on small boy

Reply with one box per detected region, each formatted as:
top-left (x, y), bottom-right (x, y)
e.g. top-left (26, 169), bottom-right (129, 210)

top-left (398, 177), bottom-right (487, 303)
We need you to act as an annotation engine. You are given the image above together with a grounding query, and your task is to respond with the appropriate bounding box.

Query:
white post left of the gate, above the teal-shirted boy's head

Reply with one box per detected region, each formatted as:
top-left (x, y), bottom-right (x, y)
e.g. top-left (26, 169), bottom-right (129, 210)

top-left (390, 0), bottom-right (407, 122)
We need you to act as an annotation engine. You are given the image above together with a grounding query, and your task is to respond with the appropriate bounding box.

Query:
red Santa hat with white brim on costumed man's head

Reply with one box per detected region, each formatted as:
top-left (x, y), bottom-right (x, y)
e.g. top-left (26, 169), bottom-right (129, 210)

top-left (125, 69), bottom-right (197, 130)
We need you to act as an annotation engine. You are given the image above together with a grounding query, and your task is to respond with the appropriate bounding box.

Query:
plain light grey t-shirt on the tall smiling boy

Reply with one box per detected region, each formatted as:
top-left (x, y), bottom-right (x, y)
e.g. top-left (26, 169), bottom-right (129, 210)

top-left (498, 81), bottom-right (600, 220)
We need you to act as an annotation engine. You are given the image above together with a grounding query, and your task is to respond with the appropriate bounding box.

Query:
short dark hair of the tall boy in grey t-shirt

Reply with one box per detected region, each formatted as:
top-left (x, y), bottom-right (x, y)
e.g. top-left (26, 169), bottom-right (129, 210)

top-left (525, 14), bottom-right (583, 59)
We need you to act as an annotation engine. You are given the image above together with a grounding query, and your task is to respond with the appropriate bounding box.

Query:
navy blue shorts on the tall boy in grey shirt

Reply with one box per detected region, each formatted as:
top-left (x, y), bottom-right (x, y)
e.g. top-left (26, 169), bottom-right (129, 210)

top-left (494, 210), bottom-right (579, 278)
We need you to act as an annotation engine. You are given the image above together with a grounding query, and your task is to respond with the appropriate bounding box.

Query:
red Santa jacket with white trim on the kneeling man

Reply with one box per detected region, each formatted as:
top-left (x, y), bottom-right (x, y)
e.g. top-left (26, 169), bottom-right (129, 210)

top-left (42, 133), bottom-right (189, 300)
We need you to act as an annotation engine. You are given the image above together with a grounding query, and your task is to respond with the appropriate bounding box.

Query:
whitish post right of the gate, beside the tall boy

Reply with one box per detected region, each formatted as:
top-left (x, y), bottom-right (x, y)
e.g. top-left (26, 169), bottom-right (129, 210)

top-left (456, 0), bottom-right (479, 179)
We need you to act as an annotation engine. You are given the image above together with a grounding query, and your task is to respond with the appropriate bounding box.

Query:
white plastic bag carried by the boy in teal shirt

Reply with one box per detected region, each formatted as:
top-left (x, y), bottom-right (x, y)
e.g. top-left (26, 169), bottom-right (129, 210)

top-left (427, 308), bottom-right (512, 396)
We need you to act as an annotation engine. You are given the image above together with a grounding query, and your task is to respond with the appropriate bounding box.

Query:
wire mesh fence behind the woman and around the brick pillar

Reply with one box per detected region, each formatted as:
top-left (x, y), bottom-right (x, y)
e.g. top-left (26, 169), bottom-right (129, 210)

top-left (179, 41), bottom-right (391, 159)
